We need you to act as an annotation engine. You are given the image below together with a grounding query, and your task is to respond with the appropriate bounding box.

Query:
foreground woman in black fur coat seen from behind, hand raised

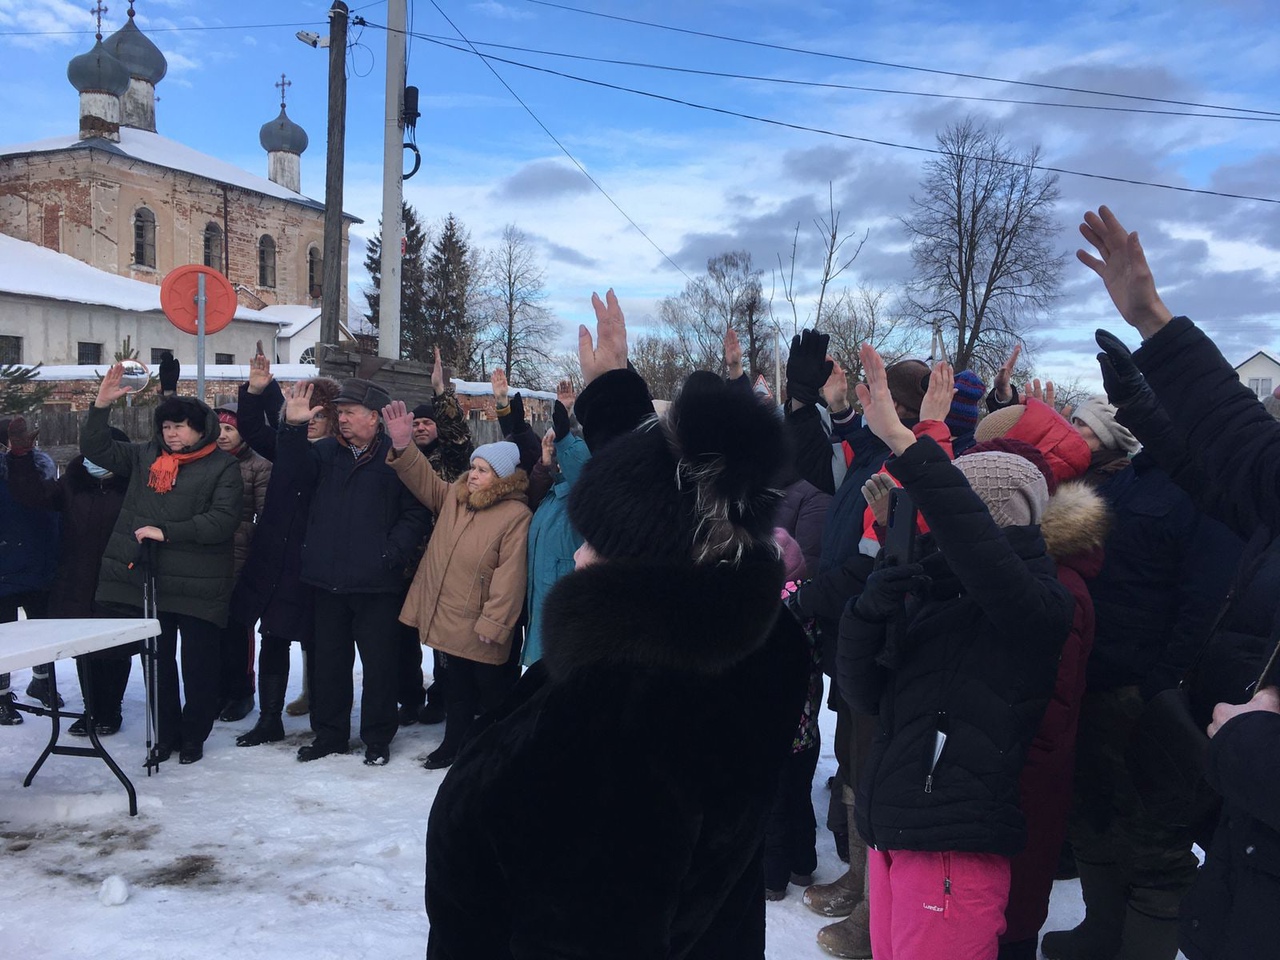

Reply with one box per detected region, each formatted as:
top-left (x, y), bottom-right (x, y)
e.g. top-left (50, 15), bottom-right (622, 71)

top-left (425, 292), bottom-right (806, 960)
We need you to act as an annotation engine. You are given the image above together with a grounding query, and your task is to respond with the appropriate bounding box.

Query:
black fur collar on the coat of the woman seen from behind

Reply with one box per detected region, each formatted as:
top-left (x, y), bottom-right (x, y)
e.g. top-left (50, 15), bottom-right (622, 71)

top-left (543, 550), bottom-right (783, 680)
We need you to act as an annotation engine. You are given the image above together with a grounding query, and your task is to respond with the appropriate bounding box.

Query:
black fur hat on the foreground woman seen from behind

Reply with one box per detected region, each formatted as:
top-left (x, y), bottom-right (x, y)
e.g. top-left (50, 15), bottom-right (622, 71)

top-left (568, 374), bottom-right (786, 563)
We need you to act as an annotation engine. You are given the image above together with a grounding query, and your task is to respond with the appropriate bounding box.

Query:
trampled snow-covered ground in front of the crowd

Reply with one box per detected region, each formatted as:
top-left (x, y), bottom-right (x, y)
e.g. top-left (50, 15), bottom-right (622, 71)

top-left (0, 646), bottom-right (1100, 960)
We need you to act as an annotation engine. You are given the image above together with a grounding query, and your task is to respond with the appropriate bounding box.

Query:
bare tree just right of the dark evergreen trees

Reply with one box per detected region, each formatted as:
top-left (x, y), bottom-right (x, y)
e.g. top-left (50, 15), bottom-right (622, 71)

top-left (483, 224), bottom-right (557, 385)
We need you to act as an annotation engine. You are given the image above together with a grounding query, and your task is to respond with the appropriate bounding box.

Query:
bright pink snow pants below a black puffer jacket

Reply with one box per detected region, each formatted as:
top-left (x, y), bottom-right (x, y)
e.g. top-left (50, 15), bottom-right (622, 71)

top-left (867, 850), bottom-right (1009, 960)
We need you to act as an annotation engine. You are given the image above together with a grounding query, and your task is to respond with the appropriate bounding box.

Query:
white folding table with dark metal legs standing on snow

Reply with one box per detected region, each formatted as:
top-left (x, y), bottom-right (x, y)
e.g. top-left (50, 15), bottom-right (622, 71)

top-left (0, 618), bottom-right (160, 817)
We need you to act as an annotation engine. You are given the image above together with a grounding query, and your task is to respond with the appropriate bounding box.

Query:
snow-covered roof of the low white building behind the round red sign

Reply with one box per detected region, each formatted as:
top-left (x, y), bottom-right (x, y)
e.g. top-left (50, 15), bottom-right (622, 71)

top-left (0, 234), bottom-right (279, 326)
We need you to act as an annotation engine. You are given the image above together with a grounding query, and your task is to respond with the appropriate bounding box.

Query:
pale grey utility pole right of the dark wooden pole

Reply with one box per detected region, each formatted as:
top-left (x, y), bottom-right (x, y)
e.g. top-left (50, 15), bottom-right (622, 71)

top-left (378, 0), bottom-right (407, 360)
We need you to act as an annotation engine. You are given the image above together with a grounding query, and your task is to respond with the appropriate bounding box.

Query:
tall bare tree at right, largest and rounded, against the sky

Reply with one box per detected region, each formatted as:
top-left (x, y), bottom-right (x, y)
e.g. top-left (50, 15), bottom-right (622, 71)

top-left (902, 118), bottom-right (1064, 370)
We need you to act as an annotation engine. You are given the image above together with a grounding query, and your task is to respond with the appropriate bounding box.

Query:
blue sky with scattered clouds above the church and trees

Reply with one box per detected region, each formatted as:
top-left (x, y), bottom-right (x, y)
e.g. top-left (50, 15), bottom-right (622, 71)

top-left (0, 0), bottom-right (1280, 391)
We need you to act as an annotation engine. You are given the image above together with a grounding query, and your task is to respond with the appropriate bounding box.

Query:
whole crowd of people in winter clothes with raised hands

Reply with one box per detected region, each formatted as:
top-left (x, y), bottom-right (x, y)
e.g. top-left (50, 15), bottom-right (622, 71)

top-left (0, 207), bottom-right (1280, 960)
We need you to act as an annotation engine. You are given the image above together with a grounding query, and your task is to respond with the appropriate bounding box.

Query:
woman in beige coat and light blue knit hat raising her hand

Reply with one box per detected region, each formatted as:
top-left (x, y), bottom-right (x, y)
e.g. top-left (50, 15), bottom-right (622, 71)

top-left (383, 401), bottom-right (531, 771)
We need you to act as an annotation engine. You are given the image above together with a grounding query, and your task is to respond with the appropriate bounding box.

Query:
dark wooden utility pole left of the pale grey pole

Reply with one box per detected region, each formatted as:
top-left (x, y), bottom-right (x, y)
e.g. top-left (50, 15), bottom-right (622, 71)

top-left (320, 0), bottom-right (347, 343)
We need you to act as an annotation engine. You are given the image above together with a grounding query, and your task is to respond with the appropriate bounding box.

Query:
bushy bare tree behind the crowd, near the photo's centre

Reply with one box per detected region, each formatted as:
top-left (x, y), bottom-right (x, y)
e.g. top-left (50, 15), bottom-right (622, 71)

top-left (658, 250), bottom-right (774, 378)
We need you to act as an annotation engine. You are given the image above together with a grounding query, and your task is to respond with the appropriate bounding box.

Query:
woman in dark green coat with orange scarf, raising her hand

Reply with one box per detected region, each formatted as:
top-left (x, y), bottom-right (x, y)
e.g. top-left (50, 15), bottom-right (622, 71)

top-left (81, 364), bottom-right (244, 763)
